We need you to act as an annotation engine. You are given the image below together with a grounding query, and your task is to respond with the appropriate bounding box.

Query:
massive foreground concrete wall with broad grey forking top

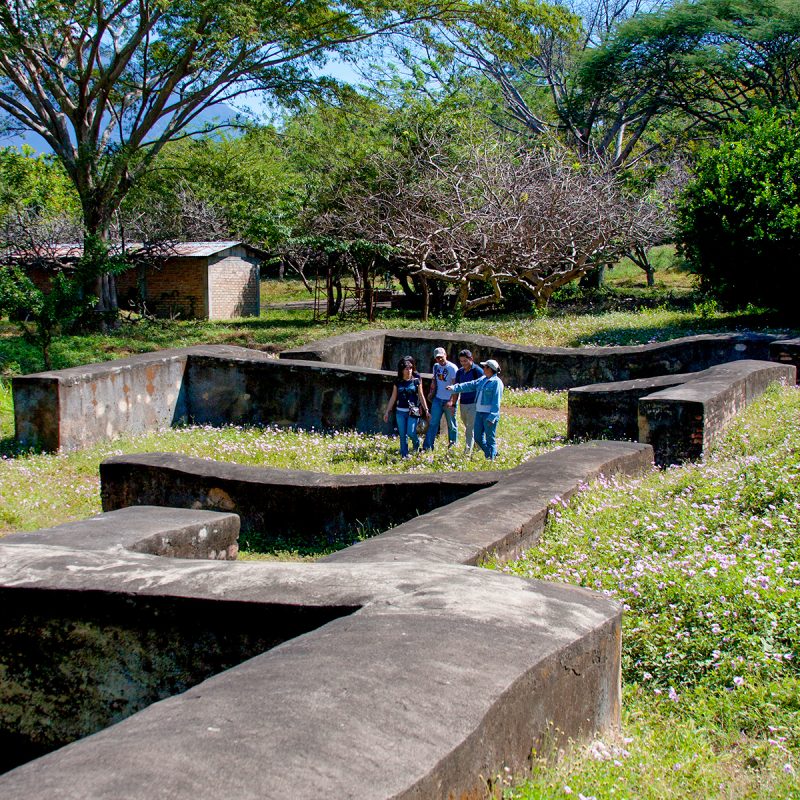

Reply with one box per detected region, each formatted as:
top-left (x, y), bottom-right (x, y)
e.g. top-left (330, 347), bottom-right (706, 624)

top-left (0, 520), bottom-right (621, 800)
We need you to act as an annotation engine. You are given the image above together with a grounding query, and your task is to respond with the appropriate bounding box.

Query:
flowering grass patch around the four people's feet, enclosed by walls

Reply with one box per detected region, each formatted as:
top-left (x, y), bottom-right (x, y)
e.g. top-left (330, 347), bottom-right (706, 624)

top-left (0, 380), bottom-right (566, 557)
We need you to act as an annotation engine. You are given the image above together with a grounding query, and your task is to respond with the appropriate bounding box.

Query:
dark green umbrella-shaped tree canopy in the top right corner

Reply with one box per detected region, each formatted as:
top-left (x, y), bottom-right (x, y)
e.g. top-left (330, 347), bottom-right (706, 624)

top-left (580, 0), bottom-right (800, 129)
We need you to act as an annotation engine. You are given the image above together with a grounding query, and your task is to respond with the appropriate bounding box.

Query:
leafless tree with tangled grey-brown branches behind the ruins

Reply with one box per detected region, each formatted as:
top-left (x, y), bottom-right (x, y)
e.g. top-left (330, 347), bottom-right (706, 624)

top-left (318, 137), bottom-right (636, 316)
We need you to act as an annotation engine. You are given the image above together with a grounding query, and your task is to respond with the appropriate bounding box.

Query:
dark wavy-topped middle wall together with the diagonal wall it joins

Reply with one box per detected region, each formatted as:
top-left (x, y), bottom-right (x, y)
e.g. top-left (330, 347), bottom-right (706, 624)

top-left (100, 442), bottom-right (653, 564)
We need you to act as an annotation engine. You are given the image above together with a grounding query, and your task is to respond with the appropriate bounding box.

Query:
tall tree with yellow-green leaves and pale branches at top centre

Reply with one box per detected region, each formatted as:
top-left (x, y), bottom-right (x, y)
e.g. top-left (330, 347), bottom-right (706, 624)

top-left (386, 0), bottom-right (676, 169)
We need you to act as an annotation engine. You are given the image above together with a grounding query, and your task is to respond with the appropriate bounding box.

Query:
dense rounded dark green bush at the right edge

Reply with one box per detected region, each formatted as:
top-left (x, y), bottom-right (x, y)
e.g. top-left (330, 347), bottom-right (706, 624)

top-left (678, 111), bottom-right (800, 311)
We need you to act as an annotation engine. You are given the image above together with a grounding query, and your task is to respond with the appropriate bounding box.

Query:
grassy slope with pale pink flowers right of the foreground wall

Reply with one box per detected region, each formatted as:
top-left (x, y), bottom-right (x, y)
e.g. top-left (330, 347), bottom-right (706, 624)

top-left (493, 388), bottom-right (800, 800)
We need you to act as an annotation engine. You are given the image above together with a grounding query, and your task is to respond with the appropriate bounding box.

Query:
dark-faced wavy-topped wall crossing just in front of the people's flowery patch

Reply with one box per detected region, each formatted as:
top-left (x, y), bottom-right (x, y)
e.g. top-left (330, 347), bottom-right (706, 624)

top-left (100, 453), bottom-right (494, 544)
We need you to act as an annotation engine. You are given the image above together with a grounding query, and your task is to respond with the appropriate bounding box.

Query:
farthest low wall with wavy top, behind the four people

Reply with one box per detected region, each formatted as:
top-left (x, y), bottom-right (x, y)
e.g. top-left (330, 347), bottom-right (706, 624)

top-left (281, 330), bottom-right (778, 390)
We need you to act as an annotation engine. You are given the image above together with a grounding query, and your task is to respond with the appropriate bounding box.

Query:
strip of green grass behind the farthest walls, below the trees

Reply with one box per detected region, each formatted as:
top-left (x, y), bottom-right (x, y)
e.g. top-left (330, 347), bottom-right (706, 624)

top-left (0, 295), bottom-right (792, 375)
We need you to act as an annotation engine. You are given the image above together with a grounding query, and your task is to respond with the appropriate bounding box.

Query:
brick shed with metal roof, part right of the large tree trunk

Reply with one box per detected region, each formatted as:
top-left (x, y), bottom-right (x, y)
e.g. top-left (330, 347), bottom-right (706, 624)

top-left (116, 242), bottom-right (265, 319)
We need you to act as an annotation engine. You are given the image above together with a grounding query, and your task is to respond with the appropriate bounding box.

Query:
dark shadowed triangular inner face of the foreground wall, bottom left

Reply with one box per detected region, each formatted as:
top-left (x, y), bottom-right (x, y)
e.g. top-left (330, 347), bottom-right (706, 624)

top-left (0, 589), bottom-right (352, 776)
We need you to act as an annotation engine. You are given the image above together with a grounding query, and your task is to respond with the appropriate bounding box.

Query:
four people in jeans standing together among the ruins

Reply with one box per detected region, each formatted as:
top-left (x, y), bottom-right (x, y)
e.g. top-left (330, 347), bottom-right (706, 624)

top-left (383, 347), bottom-right (503, 459)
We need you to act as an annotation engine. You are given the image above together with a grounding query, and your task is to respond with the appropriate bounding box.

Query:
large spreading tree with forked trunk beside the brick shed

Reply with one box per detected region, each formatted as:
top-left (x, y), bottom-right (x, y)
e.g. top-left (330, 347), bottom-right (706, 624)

top-left (0, 0), bottom-right (450, 314)
